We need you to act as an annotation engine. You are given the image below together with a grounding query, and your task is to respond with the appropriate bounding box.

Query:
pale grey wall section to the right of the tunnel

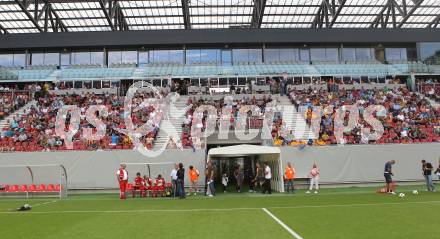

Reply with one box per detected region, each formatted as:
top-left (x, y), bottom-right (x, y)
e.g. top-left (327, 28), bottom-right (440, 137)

top-left (281, 143), bottom-right (440, 183)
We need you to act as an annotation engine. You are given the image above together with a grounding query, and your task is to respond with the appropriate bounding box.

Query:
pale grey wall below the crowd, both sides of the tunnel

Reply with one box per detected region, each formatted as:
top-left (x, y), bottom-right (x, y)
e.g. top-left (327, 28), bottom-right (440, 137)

top-left (0, 143), bottom-right (440, 188)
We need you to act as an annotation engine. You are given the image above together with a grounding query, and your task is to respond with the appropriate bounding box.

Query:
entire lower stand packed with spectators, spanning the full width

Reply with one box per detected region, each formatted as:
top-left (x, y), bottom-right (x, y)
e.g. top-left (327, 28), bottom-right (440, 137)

top-left (0, 75), bottom-right (440, 151)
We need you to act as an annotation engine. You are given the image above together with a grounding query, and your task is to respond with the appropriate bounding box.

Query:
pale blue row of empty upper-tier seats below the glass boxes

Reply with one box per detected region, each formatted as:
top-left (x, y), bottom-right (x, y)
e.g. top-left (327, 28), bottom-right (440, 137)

top-left (0, 62), bottom-right (437, 80)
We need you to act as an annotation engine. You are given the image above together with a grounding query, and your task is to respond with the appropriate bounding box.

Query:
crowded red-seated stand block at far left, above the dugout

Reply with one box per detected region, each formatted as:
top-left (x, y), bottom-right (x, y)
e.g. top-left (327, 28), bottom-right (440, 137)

top-left (0, 93), bottom-right (162, 151)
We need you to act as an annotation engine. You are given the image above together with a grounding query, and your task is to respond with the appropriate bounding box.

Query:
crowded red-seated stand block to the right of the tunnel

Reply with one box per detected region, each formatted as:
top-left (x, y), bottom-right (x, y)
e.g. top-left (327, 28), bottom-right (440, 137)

top-left (280, 88), bottom-right (440, 145)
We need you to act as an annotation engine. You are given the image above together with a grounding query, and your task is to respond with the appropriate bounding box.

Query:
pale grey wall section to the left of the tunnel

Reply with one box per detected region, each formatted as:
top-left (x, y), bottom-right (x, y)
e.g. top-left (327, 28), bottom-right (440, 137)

top-left (0, 150), bottom-right (205, 189)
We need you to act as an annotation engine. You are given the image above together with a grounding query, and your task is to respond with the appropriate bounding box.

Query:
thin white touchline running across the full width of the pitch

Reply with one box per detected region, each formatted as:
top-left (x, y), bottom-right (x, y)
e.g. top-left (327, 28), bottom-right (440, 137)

top-left (0, 201), bottom-right (440, 214)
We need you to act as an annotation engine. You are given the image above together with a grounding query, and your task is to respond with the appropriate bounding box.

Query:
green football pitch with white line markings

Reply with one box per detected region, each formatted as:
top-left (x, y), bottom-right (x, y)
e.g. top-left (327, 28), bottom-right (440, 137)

top-left (0, 186), bottom-right (440, 239)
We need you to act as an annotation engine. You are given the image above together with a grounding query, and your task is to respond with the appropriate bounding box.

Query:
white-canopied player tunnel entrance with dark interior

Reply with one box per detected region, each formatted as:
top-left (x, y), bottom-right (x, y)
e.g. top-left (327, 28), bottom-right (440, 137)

top-left (207, 144), bottom-right (284, 192)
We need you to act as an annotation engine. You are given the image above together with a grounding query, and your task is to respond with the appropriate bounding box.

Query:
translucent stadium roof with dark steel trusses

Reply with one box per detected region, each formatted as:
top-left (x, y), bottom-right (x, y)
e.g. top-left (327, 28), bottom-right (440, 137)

top-left (0, 0), bottom-right (440, 33)
